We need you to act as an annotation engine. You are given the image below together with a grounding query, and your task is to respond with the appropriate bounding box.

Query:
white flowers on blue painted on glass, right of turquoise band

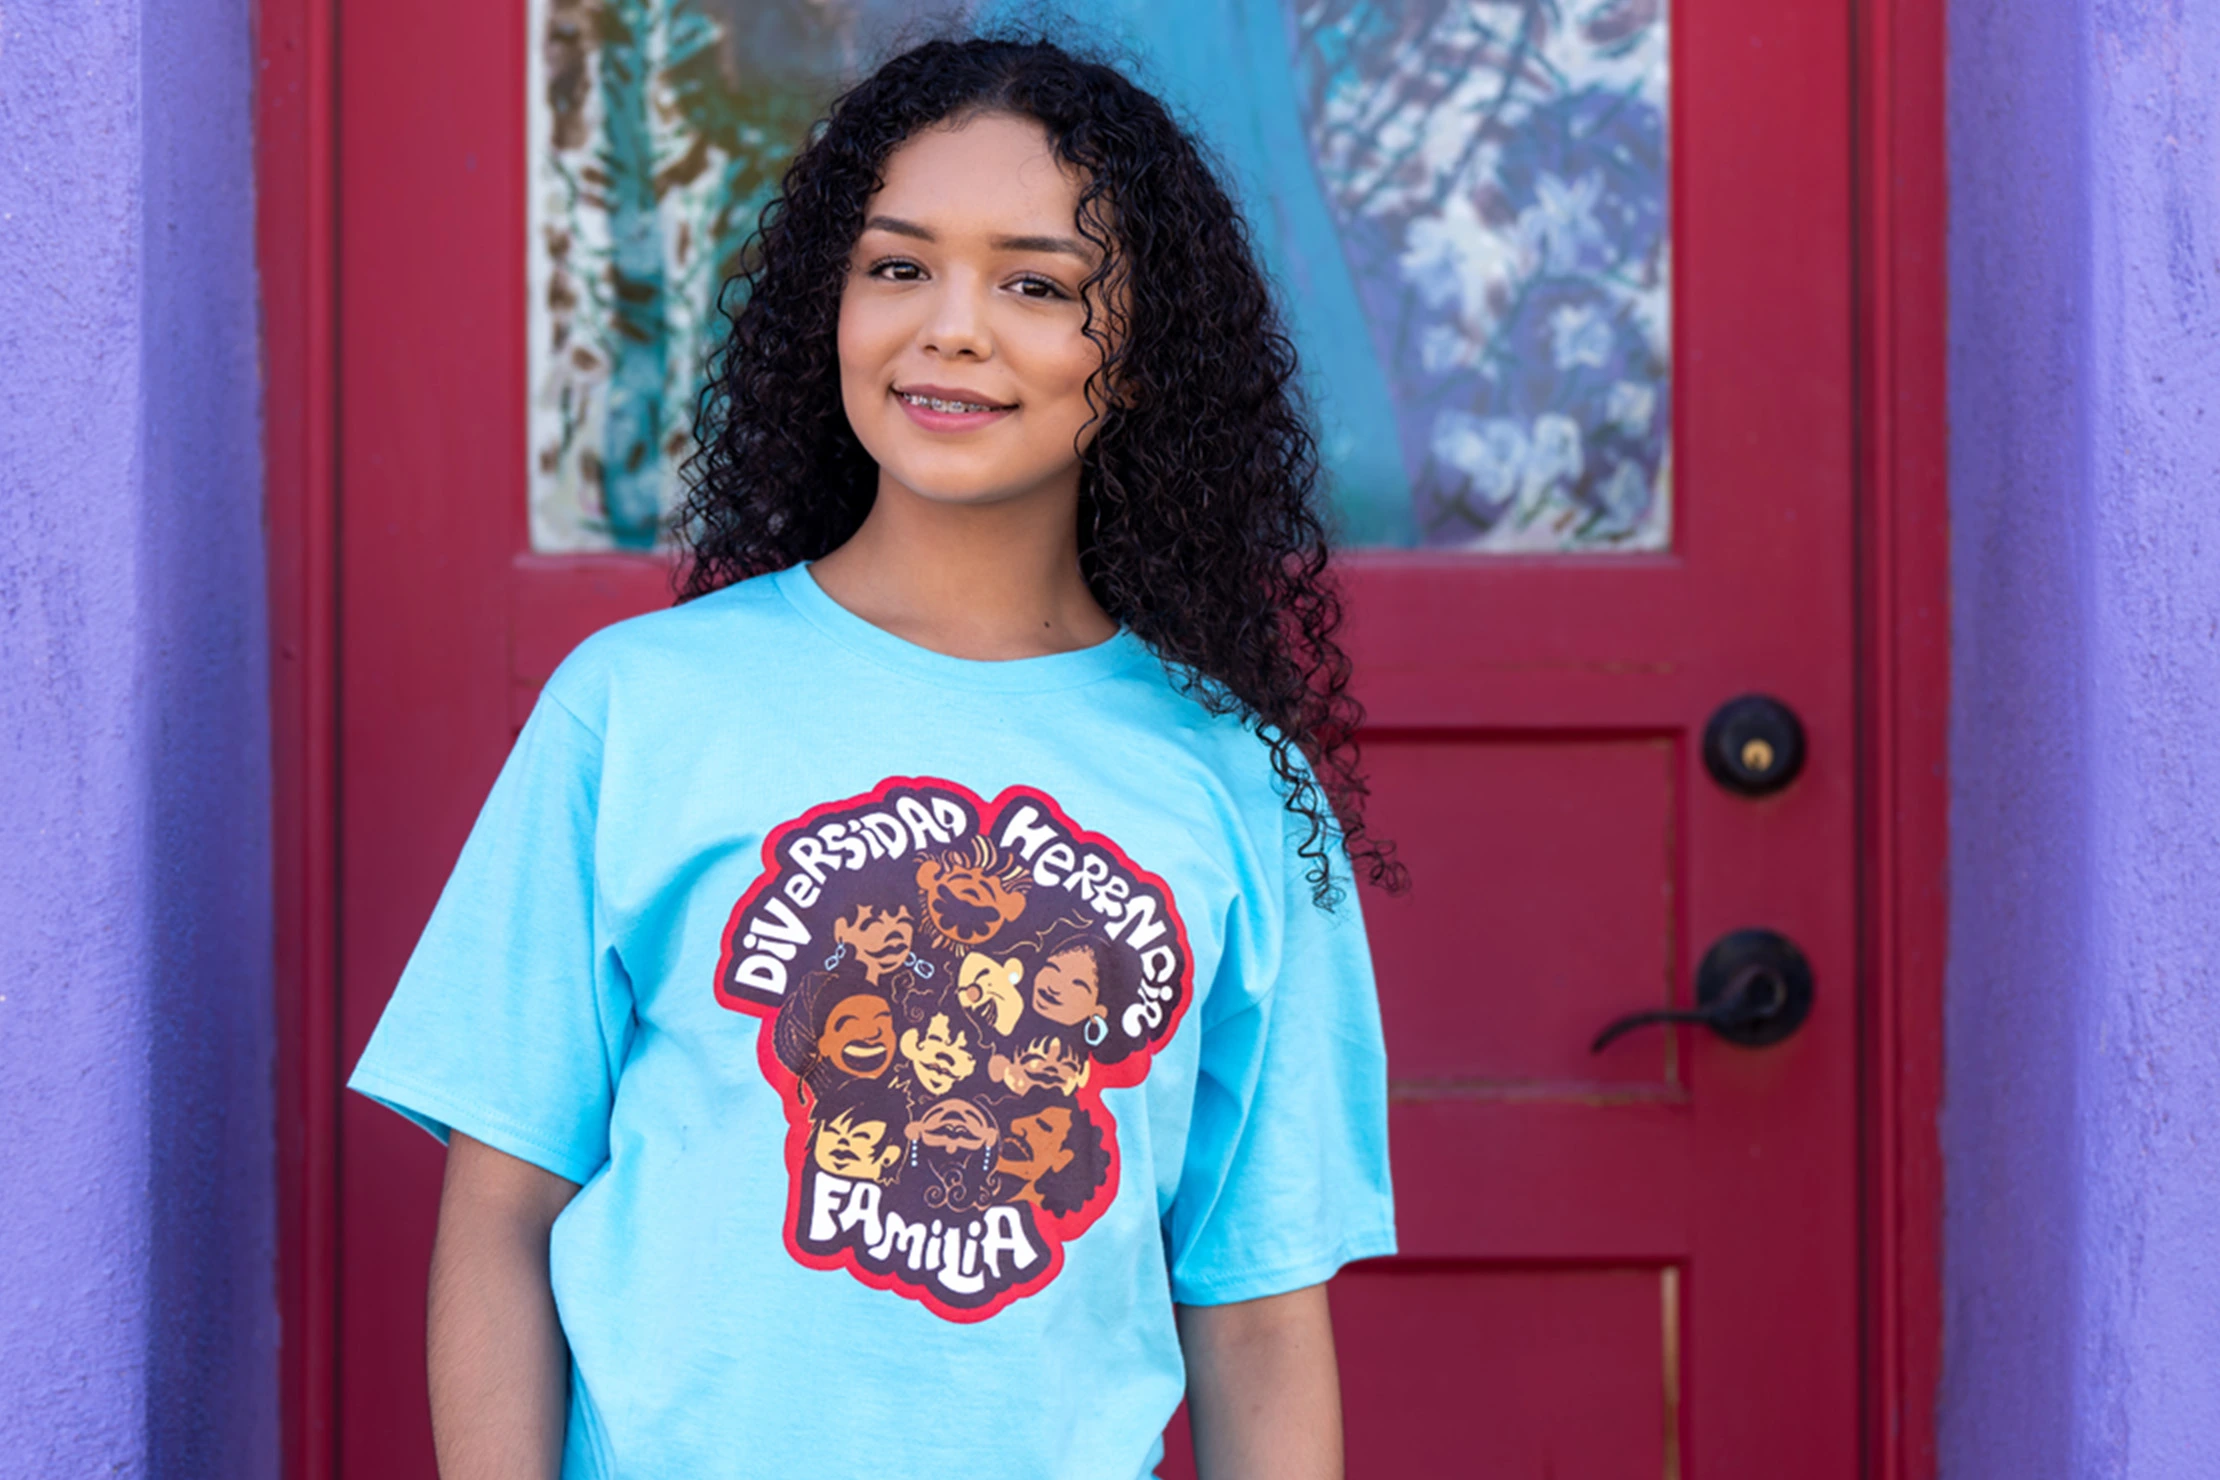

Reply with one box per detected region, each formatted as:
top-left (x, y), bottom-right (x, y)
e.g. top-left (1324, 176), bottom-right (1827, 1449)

top-left (1292, 0), bottom-right (1672, 553)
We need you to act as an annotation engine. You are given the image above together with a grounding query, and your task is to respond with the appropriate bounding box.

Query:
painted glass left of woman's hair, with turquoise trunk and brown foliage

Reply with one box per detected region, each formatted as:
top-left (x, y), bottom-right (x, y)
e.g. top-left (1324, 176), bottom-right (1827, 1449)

top-left (526, 0), bottom-right (963, 553)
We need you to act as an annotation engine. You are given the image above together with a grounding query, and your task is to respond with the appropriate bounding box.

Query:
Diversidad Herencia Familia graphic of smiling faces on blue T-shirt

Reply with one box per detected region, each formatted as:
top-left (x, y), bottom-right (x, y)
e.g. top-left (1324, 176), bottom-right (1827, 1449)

top-left (717, 777), bottom-right (1194, 1320)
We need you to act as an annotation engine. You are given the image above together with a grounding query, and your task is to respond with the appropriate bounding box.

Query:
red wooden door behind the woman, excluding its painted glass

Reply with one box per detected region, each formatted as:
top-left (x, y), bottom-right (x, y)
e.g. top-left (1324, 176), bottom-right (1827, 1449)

top-left (333, 0), bottom-right (1891, 1480)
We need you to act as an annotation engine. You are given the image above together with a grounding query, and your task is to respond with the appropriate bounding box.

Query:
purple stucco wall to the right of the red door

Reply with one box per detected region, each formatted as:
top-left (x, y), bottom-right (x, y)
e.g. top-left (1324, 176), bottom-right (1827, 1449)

top-left (1940, 0), bottom-right (2220, 1480)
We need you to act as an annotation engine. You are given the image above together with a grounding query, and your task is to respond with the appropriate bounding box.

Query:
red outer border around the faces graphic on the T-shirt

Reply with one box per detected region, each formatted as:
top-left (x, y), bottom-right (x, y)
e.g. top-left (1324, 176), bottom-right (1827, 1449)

top-left (717, 777), bottom-right (1194, 1325)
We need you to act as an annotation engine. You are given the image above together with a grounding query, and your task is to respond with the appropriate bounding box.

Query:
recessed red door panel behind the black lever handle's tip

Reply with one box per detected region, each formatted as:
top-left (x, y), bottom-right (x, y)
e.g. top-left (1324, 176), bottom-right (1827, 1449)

top-left (1365, 730), bottom-right (1681, 1098)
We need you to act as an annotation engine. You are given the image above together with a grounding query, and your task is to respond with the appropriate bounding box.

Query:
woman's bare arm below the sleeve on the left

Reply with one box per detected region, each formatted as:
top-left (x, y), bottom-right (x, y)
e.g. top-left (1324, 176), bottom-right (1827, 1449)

top-left (428, 1132), bottom-right (577, 1480)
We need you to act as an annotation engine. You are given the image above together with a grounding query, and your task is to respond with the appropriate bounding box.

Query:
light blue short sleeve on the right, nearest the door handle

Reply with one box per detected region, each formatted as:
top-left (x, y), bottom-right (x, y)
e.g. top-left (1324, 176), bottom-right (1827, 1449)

top-left (1168, 812), bottom-right (1394, 1305)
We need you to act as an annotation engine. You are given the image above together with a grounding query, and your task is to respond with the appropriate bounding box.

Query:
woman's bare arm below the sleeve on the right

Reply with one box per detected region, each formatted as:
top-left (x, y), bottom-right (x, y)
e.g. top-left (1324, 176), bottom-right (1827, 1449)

top-left (1177, 1285), bottom-right (1341, 1480)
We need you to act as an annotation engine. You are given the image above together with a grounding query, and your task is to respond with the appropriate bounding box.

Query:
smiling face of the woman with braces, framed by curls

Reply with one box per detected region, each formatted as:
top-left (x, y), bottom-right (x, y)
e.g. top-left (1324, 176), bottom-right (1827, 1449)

top-left (839, 113), bottom-right (1101, 506)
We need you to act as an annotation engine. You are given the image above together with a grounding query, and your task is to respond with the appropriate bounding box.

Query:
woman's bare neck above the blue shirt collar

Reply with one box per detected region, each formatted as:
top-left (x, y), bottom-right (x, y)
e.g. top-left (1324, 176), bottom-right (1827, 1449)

top-left (810, 479), bottom-right (1117, 659)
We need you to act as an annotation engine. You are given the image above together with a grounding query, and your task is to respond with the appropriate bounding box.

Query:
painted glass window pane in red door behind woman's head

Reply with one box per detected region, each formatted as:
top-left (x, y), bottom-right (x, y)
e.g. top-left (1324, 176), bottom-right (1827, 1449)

top-left (528, 0), bottom-right (1672, 553)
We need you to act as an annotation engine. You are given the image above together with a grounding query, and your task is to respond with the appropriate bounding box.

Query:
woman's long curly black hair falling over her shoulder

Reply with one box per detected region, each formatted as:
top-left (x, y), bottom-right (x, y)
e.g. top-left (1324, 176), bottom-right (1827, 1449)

top-left (677, 36), bottom-right (1403, 908)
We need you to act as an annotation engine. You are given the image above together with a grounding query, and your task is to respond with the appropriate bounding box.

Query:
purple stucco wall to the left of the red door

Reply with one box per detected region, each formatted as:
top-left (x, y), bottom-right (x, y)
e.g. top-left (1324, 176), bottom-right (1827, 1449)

top-left (0, 0), bottom-right (278, 1478)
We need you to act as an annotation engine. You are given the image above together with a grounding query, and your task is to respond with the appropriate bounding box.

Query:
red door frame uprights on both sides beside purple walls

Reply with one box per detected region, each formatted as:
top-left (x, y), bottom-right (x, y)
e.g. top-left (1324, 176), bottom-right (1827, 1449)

top-left (255, 0), bottom-right (1949, 1480)
